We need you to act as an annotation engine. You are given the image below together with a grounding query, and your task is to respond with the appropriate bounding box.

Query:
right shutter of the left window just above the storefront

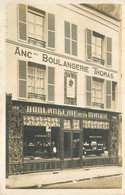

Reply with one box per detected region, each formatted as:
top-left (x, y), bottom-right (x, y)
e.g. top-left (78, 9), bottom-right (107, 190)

top-left (48, 67), bottom-right (55, 101)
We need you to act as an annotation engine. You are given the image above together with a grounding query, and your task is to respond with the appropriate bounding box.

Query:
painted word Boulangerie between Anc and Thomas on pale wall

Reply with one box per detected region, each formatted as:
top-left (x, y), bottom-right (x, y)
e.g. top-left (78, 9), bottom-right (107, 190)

top-left (42, 54), bottom-right (89, 73)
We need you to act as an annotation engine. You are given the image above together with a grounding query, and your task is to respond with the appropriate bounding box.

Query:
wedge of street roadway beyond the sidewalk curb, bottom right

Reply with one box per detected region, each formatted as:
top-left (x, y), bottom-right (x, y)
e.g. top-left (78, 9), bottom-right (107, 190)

top-left (42, 175), bottom-right (122, 189)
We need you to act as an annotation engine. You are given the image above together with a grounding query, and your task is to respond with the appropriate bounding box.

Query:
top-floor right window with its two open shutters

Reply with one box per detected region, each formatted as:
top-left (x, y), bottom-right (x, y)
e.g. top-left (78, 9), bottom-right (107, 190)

top-left (86, 29), bottom-right (112, 66)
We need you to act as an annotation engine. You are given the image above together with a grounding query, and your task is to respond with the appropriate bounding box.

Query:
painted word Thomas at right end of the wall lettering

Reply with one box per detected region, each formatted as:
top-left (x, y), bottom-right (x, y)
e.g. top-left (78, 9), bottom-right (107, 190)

top-left (92, 67), bottom-right (113, 79)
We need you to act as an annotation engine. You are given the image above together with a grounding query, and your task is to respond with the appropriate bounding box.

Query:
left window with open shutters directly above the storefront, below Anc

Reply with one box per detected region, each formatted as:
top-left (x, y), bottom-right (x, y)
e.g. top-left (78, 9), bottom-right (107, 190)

top-left (19, 60), bottom-right (55, 101)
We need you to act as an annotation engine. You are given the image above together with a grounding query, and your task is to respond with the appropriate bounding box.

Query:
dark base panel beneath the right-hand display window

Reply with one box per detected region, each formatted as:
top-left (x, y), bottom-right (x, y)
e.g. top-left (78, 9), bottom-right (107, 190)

top-left (82, 157), bottom-right (118, 166)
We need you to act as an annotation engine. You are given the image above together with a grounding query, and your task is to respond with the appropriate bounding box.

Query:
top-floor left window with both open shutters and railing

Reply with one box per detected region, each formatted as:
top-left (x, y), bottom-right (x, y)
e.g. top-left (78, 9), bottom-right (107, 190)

top-left (18, 4), bottom-right (55, 48)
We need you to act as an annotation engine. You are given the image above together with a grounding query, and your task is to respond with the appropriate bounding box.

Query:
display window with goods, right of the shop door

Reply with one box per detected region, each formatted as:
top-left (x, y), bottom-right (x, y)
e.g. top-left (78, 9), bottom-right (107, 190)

top-left (83, 129), bottom-right (109, 157)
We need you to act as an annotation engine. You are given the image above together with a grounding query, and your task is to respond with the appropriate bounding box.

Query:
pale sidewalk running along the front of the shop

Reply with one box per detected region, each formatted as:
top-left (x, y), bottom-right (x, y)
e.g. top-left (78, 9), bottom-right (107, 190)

top-left (6, 166), bottom-right (122, 188)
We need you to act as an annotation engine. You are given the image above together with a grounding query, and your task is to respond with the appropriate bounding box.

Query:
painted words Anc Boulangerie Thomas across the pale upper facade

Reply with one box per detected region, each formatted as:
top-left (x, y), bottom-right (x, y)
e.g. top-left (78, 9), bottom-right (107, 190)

top-left (14, 47), bottom-right (114, 79)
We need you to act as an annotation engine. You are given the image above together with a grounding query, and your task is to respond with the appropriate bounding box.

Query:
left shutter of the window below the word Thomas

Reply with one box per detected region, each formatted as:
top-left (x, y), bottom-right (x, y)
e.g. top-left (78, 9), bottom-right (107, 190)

top-left (86, 76), bottom-right (91, 106)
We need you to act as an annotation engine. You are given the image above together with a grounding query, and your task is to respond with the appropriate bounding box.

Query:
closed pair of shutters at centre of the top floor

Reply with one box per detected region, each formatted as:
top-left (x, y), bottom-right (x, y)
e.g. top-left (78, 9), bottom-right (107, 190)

top-left (65, 21), bottom-right (77, 56)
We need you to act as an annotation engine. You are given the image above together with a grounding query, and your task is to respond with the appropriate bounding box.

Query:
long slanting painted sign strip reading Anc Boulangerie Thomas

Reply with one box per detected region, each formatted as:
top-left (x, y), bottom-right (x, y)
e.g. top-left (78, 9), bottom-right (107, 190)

top-left (14, 46), bottom-right (117, 80)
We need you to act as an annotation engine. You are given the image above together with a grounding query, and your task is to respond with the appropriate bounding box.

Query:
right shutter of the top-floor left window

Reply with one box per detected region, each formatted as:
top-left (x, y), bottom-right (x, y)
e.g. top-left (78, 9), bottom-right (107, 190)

top-left (48, 13), bottom-right (55, 48)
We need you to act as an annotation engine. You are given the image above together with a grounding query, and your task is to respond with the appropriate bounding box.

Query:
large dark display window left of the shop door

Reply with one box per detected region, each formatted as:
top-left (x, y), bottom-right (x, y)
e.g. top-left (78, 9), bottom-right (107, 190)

top-left (23, 126), bottom-right (60, 160)
